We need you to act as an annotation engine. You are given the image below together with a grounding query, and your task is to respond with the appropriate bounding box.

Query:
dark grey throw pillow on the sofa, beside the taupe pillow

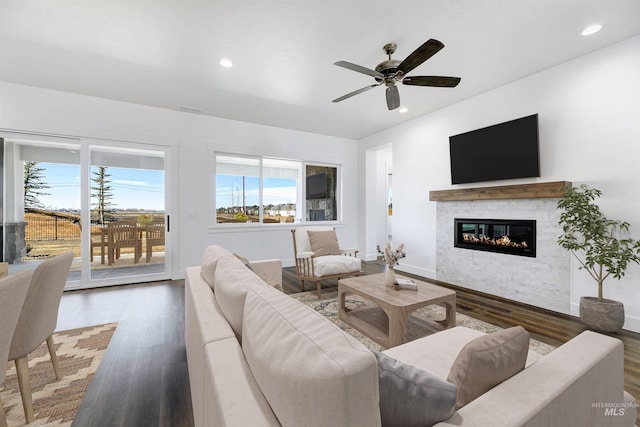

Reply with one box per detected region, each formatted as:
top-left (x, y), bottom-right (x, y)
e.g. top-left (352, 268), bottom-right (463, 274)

top-left (374, 351), bottom-right (457, 427)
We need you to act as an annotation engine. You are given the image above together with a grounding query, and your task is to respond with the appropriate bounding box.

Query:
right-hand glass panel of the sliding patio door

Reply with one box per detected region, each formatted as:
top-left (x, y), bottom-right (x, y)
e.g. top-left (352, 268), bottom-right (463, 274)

top-left (84, 145), bottom-right (171, 288)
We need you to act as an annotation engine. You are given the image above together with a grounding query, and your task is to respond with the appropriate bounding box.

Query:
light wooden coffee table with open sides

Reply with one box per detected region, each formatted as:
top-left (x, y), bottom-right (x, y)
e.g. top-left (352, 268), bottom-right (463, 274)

top-left (338, 274), bottom-right (456, 348)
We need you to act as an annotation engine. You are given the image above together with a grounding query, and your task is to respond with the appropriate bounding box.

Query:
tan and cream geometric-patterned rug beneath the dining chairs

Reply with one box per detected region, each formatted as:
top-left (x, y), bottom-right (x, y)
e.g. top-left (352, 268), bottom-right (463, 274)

top-left (0, 323), bottom-right (118, 427)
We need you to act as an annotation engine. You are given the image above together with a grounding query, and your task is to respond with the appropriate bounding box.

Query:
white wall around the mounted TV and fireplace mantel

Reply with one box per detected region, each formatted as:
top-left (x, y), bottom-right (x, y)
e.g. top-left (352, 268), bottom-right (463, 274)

top-left (360, 37), bottom-right (640, 331)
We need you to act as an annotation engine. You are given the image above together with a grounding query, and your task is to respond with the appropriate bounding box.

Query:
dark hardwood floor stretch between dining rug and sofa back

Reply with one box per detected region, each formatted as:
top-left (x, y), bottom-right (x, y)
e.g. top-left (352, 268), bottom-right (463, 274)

top-left (57, 280), bottom-right (193, 427)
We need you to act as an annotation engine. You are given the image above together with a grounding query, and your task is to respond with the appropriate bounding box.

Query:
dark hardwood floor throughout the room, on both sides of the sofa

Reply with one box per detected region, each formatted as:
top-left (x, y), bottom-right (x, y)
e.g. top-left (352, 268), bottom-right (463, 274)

top-left (57, 261), bottom-right (640, 427)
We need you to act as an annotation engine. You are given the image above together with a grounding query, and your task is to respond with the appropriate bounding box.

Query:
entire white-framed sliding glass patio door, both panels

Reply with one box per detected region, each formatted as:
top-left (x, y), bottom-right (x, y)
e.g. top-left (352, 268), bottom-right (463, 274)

top-left (0, 135), bottom-right (171, 289)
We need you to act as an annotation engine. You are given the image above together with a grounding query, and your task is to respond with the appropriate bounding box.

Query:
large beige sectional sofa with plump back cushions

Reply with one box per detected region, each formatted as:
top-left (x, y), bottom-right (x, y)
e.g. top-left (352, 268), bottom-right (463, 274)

top-left (185, 246), bottom-right (636, 427)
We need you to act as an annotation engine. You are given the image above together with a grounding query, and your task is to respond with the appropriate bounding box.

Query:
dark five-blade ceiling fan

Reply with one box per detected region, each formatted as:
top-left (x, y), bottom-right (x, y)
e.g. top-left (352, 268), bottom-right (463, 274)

top-left (333, 39), bottom-right (460, 110)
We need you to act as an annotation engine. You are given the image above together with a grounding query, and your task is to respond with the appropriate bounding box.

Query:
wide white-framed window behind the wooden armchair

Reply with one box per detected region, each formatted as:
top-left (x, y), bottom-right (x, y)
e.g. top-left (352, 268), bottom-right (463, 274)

top-left (215, 154), bottom-right (338, 224)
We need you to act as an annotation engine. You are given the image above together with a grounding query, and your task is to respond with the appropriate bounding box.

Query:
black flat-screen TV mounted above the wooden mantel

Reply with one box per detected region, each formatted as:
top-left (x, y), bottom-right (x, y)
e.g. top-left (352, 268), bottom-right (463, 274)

top-left (449, 114), bottom-right (540, 184)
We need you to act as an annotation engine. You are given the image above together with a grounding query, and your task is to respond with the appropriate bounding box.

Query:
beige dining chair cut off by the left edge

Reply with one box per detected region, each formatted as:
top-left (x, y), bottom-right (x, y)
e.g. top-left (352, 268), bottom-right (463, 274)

top-left (0, 271), bottom-right (33, 427)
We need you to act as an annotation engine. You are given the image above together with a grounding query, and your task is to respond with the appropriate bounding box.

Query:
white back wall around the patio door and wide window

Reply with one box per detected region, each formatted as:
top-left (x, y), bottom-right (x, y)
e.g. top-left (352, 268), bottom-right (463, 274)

top-left (0, 82), bottom-right (358, 277)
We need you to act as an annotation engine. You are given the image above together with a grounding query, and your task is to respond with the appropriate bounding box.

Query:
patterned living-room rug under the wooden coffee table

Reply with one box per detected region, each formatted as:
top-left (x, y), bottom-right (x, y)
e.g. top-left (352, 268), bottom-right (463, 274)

top-left (290, 291), bottom-right (555, 355)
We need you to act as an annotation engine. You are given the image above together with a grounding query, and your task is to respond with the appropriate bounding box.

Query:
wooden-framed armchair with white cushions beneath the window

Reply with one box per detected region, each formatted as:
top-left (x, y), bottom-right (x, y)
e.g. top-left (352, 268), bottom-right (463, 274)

top-left (291, 226), bottom-right (362, 299)
